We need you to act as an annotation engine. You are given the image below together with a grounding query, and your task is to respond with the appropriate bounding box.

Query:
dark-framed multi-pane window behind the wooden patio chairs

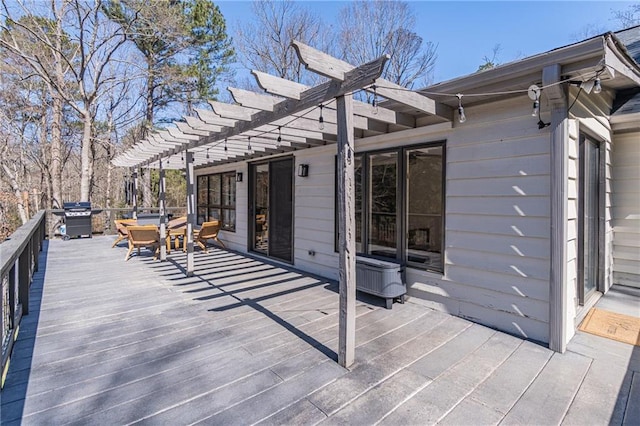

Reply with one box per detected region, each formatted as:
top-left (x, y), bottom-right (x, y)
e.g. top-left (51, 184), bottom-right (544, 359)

top-left (198, 172), bottom-right (236, 231)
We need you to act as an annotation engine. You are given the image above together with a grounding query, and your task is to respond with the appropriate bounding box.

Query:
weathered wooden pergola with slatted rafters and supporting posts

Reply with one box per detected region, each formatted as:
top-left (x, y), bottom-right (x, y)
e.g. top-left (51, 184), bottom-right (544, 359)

top-left (113, 42), bottom-right (453, 367)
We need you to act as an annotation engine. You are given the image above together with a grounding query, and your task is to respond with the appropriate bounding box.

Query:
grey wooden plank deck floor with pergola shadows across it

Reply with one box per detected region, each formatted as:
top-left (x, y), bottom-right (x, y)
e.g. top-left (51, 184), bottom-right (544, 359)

top-left (0, 238), bottom-right (640, 425)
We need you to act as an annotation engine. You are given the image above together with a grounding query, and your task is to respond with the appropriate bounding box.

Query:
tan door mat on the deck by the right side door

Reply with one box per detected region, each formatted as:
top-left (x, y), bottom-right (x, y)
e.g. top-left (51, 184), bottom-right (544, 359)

top-left (578, 308), bottom-right (640, 346)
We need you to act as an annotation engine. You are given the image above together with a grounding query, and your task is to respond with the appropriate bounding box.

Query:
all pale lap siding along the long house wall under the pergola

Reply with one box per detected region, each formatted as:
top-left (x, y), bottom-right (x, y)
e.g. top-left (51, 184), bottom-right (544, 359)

top-left (195, 97), bottom-right (550, 341)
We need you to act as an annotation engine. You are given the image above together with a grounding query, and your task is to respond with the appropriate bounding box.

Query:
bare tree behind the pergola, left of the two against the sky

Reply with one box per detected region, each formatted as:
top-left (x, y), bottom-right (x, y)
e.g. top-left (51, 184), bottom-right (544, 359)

top-left (235, 0), bottom-right (334, 85)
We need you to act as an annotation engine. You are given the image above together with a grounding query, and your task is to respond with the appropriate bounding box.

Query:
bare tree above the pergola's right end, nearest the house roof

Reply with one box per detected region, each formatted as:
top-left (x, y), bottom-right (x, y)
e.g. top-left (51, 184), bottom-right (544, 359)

top-left (339, 0), bottom-right (437, 88)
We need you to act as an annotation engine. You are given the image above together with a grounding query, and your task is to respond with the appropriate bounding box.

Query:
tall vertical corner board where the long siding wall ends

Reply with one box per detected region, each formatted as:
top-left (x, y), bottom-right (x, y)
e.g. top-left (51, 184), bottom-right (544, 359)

top-left (542, 64), bottom-right (569, 353)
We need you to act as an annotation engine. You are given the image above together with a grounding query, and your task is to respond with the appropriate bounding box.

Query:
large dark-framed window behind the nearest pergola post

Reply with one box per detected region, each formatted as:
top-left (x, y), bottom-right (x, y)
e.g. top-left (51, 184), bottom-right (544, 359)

top-left (336, 142), bottom-right (445, 272)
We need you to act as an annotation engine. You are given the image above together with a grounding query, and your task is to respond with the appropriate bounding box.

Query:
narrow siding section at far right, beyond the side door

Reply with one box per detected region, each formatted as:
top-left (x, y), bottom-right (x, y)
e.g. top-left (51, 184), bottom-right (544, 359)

top-left (611, 132), bottom-right (640, 287)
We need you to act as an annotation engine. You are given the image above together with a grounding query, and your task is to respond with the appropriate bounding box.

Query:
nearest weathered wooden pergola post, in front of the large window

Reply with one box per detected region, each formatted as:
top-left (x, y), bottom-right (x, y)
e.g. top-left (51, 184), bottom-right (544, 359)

top-left (336, 95), bottom-right (356, 368)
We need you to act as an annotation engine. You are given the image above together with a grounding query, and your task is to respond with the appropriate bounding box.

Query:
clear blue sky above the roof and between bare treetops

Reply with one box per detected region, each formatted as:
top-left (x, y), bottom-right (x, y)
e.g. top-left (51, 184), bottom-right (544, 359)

top-left (217, 1), bottom-right (638, 82)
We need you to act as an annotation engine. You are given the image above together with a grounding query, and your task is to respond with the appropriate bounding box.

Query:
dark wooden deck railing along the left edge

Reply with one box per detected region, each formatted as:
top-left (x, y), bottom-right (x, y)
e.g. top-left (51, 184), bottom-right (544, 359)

top-left (0, 210), bottom-right (46, 387)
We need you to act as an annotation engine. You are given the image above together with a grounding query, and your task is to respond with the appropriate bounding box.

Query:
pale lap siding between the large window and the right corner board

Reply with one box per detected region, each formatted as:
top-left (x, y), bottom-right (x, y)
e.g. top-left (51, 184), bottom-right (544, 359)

top-left (407, 98), bottom-right (550, 341)
